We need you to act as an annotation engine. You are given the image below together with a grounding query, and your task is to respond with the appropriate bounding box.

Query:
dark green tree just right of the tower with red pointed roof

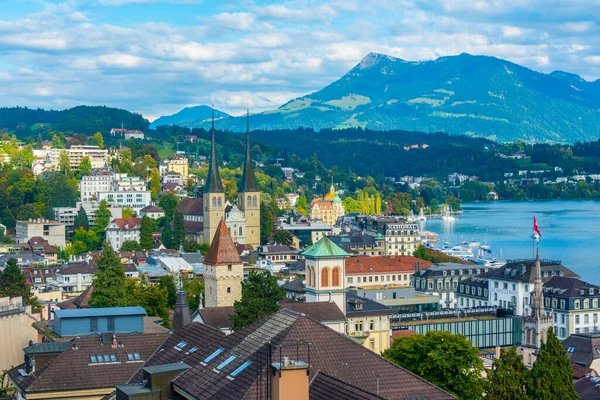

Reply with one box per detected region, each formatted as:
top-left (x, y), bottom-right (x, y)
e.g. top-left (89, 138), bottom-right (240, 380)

top-left (231, 271), bottom-right (285, 331)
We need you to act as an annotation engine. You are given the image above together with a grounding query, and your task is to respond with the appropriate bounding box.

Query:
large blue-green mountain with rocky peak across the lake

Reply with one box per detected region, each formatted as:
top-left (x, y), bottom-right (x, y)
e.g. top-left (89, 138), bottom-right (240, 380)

top-left (156, 53), bottom-right (600, 143)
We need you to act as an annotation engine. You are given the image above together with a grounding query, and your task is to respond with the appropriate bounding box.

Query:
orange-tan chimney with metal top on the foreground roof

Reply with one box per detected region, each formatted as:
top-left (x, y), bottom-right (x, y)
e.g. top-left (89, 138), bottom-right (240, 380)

top-left (271, 357), bottom-right (310, 400)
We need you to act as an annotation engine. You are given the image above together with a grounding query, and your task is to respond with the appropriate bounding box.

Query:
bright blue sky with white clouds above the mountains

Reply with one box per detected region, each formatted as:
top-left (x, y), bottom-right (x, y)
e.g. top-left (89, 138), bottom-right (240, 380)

top-left (0, 0), bottom-right (600, 120)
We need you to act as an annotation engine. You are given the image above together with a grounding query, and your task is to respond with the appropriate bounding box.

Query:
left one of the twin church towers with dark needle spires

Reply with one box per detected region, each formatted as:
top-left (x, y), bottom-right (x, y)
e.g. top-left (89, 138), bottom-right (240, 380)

top-left (203, 108), bottom-right (225, 242)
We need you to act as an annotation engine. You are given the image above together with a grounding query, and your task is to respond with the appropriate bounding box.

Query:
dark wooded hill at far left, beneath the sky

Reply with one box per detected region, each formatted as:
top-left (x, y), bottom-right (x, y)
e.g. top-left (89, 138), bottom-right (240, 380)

top-left (0, 106), bottom-right (150, 138)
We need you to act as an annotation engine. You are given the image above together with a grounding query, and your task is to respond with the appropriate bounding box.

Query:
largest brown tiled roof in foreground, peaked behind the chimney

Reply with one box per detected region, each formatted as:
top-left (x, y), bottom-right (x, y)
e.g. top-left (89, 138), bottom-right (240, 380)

top-left (173, 309), bottom-right (454, 400)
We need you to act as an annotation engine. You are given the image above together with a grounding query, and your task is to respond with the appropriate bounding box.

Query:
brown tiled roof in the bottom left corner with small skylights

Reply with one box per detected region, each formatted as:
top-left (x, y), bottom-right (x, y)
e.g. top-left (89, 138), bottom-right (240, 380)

top-left (9, 333), bottom-right (169, 393)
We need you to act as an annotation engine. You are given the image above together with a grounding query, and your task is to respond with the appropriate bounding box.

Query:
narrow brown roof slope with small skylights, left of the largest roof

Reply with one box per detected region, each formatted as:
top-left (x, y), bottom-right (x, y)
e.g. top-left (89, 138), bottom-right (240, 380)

top-left (129, 322), bottom-right (225, 383)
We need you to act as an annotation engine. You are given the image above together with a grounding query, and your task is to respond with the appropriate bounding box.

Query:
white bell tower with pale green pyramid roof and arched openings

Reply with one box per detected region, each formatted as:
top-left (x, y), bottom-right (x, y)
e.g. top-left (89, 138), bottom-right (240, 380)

top-left (302, 236), bottom-right (349, 315)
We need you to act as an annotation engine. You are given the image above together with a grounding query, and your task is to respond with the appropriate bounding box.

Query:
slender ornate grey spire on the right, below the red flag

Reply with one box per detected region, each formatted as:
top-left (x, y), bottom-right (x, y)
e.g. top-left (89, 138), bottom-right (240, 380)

top-left (521, 249), bottom-right (554, 367)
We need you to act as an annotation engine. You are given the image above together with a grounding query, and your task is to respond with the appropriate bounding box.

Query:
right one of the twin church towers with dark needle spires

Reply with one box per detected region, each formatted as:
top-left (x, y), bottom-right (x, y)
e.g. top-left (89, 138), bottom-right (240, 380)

top-left (238, 111), bottom-right (260, 249)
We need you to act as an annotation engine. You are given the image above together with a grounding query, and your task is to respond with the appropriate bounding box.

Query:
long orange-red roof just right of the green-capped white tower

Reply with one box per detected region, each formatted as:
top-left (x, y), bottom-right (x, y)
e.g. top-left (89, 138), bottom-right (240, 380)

top-left (346, 256), bottom-right (431, 275)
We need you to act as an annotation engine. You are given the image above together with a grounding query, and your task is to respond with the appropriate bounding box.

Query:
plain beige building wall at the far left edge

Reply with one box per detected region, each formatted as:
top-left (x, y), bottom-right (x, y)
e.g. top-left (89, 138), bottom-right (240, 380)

top-left (0, 297), bottom-right (39, 371)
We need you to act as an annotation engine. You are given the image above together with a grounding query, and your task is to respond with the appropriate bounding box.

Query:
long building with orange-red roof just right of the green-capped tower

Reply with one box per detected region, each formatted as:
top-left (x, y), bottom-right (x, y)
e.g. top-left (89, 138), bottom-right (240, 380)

top-left (346, 256), bottom-right (432, 288)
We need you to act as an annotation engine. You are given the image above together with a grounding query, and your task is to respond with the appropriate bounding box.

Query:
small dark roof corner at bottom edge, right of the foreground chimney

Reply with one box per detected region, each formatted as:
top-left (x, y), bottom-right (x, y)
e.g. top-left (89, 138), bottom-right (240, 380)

top-left (309, 372), bottom-right (385, 400)
